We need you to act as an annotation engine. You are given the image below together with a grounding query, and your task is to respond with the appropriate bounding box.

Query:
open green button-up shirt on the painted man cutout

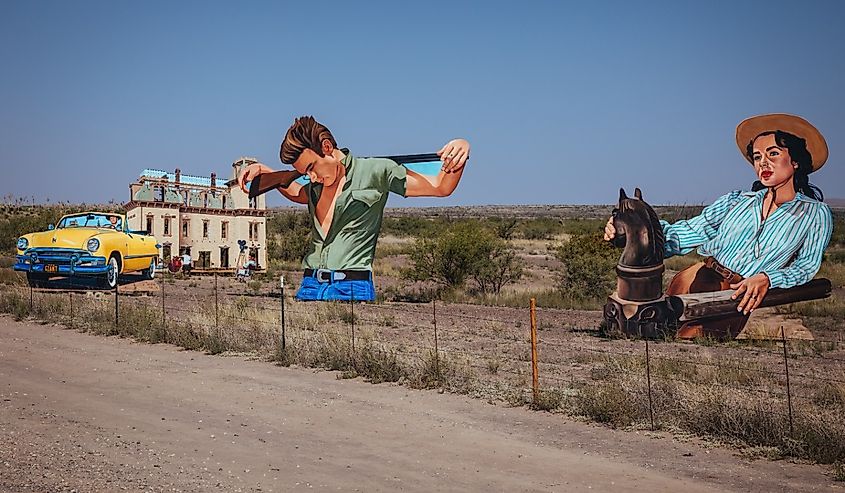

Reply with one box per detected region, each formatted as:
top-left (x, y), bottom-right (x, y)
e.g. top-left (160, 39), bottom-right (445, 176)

top-left (302, 152), bottom-right (408, 270)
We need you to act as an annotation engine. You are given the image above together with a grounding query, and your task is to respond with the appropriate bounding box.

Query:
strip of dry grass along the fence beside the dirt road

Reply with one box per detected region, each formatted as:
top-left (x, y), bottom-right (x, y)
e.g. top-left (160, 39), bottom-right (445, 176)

top-left (0, 280), bottom-right (845, 467)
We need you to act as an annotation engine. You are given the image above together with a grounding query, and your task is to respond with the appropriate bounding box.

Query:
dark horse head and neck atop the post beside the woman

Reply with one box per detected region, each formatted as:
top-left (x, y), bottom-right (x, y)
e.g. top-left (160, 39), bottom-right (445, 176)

top-left (613, 188), bottom-right (665, 268)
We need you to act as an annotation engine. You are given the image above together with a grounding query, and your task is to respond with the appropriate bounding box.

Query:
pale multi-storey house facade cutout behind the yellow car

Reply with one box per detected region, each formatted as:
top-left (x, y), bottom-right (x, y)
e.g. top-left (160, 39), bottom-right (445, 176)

top-left (126, 157), bottom-right (267, 271)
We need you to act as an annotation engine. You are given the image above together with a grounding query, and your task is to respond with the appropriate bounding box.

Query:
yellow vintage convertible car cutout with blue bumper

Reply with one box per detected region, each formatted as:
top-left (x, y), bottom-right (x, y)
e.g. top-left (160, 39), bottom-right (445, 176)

top-left (15, 212), bottom-right (159, 288)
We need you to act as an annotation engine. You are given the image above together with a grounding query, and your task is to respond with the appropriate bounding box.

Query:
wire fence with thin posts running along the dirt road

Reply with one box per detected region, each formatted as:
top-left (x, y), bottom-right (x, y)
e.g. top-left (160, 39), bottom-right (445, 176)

top-left (4, 273), bottom-right (845, 460)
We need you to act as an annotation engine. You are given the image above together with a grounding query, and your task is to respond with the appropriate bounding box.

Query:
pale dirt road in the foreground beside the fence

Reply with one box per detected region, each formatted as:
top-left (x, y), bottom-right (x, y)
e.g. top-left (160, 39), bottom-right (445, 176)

top-left (0, 317), bottom-right (842, 493)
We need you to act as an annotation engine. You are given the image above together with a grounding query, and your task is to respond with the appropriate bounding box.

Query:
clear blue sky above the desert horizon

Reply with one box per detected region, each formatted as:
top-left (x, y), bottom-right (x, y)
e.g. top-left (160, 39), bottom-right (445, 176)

top-left (0, 0), bottom-right (845, 206)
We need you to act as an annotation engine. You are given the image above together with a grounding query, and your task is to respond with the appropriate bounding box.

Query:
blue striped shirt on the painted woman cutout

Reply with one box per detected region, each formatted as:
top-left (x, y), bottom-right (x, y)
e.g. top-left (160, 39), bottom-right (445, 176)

top-left (660, 189), bottom-right (833, 288)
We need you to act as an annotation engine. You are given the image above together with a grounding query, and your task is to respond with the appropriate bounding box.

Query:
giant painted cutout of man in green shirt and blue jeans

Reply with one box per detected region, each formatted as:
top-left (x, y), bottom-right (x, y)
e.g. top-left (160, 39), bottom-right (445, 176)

top-left (238, 116), bottom-right (470, 301)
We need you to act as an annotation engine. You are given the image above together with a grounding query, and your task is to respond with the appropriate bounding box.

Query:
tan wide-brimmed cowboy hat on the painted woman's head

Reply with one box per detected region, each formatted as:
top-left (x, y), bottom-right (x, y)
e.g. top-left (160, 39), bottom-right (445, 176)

top-left (736, 113), bottom-right (827, 171)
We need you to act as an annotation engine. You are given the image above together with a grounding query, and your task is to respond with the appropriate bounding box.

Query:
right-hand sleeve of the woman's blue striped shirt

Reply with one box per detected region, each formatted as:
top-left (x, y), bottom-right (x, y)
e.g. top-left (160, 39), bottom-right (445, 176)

top-left (763, 204), bottom-right (833, 288)
